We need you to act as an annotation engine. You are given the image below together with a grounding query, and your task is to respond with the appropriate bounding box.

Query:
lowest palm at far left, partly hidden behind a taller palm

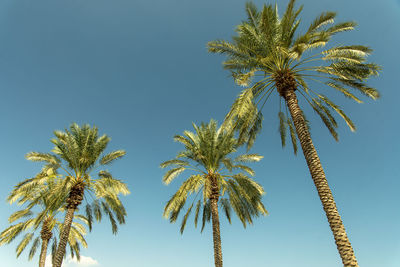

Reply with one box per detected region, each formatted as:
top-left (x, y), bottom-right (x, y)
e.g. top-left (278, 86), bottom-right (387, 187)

top-left (0, 173), bottom-right (88, 267)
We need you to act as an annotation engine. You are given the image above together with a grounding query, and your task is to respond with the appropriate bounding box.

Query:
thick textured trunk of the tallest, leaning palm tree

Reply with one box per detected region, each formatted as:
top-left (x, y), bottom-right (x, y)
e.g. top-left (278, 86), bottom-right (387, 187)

top-left (283, 90), bottom-right (358, 267)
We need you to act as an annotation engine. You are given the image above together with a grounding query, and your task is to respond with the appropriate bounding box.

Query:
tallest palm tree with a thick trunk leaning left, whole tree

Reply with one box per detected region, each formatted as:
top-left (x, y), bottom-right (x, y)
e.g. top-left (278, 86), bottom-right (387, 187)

top-left (208, 0), bottom-right (380, 266)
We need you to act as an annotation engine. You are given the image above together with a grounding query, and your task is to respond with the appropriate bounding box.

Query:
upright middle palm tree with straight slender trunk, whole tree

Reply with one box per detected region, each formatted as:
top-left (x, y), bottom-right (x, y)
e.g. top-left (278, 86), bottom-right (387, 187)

top-left (160, 120), bottom-right (267, 267)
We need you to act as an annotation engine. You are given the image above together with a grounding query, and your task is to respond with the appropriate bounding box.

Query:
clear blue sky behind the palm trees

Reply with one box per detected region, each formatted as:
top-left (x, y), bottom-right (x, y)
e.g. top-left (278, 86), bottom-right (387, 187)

top-left (0, 0), bottom-right (400, 267)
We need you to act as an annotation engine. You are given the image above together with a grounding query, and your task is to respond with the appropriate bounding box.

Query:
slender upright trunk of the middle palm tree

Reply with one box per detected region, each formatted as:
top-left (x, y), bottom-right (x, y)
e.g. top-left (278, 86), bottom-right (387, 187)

top-left (210, 175), bottom-right (222, 267)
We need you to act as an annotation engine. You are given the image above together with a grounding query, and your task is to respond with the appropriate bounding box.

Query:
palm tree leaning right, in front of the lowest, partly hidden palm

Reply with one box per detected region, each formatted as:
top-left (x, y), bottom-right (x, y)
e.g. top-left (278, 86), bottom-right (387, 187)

top-left (26, 123), bottom-right (129, 267)
